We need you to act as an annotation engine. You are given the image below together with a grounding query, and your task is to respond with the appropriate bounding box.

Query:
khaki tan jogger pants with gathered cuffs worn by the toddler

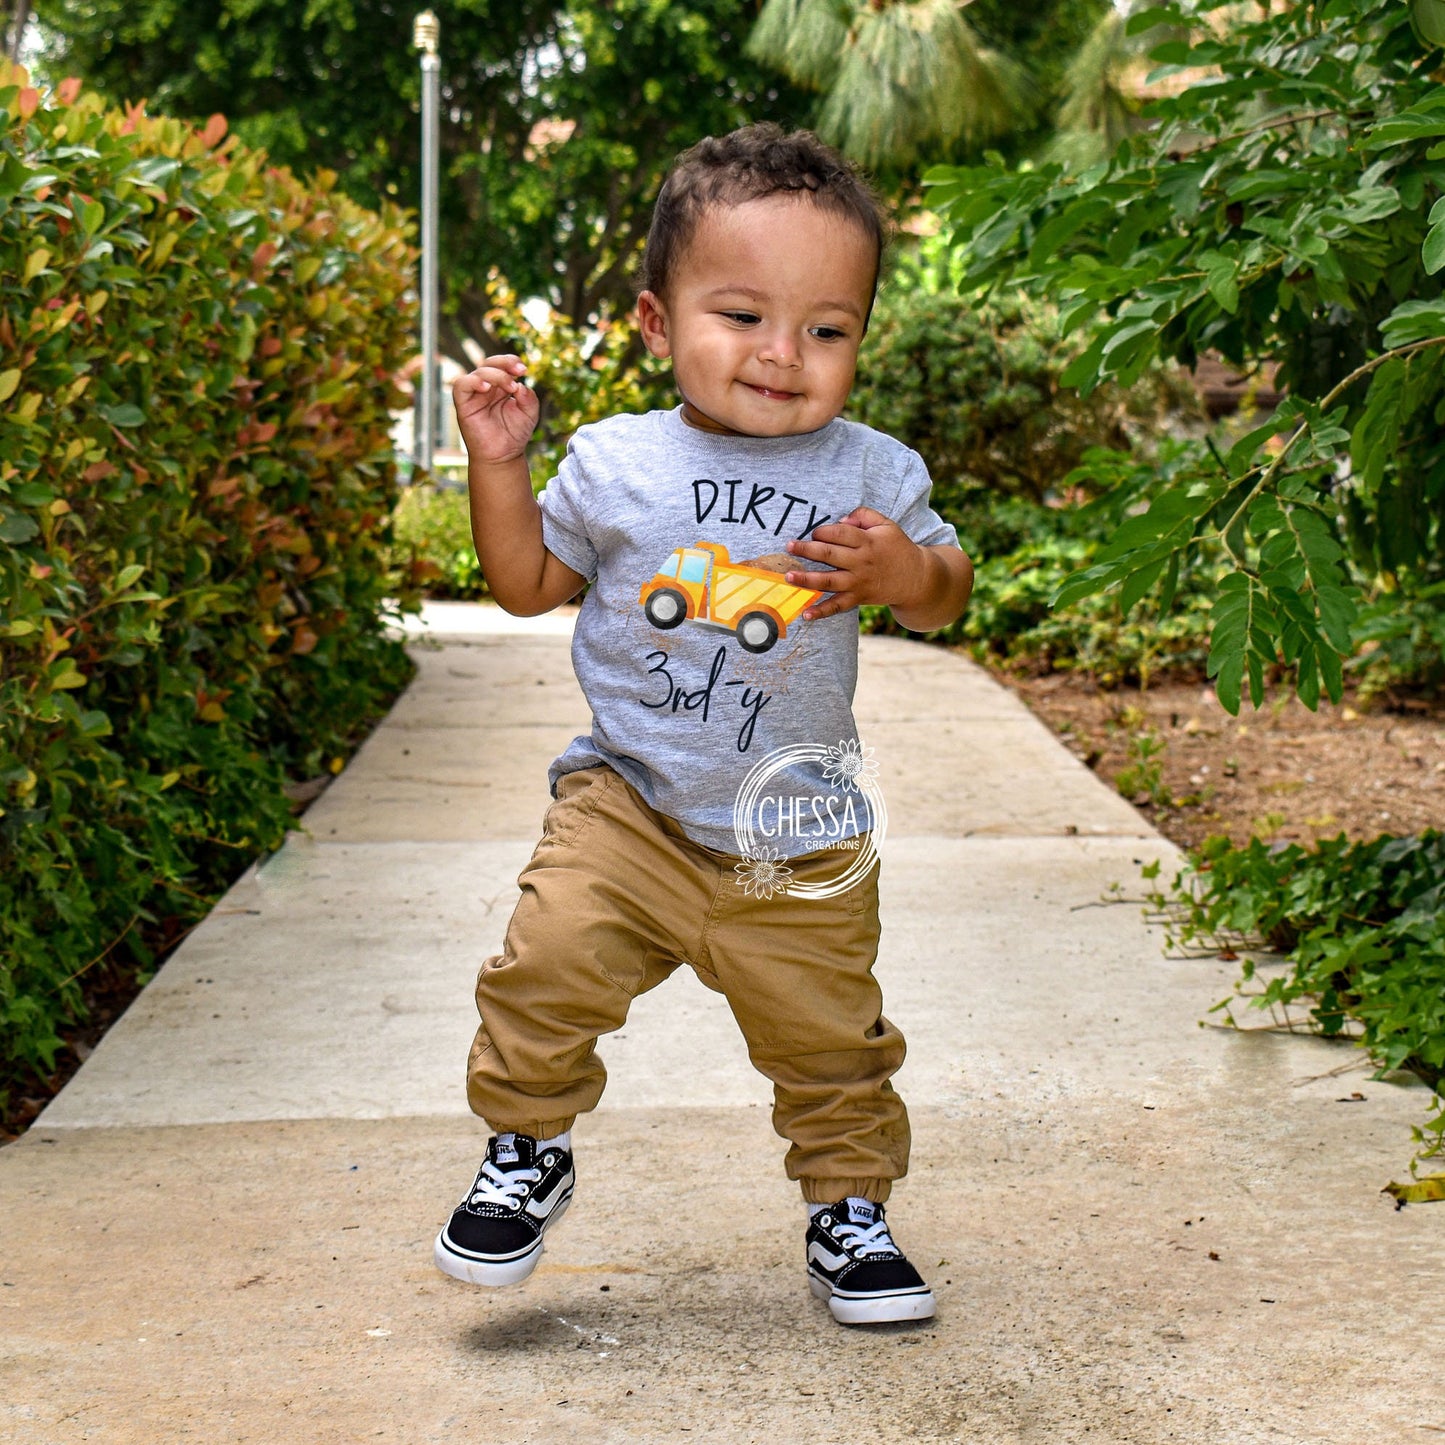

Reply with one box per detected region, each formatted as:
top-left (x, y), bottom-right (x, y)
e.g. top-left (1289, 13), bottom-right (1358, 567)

top-left (467, 766), bottom-right (909, 1204)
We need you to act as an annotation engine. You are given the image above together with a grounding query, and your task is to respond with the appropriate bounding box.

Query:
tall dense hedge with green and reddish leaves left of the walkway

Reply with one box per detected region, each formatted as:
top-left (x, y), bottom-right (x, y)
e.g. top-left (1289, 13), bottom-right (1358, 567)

top-left (0, 65), bottom-right (413, 1092)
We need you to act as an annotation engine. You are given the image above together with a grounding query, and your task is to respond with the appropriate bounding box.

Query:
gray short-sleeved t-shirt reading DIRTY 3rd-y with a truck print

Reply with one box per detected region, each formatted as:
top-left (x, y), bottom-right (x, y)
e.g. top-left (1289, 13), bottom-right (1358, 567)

top-left (538, 407), bottom-right (958, 857)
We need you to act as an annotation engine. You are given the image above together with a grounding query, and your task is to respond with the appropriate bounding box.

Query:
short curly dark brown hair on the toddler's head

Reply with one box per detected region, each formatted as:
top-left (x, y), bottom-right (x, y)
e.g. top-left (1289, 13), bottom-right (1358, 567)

top-left (642, 121), bottom-right (890, 313)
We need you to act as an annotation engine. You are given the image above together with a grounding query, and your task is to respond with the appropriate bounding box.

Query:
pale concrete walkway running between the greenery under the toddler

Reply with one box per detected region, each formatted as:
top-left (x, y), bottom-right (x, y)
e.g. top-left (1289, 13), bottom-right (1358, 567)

top-left (0, 607), bottom-right (1445, 1445)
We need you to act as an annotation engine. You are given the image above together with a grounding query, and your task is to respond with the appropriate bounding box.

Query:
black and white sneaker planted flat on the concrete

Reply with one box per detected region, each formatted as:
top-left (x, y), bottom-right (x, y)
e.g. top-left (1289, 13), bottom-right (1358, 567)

top-left (808, 1199), bottom-right (933, 1325)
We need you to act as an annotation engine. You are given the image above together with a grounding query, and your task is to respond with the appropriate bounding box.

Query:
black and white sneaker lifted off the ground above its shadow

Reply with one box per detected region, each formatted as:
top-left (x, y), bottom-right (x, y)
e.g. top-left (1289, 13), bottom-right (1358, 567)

top-left (432, 1134), bottom-right (574, 1285)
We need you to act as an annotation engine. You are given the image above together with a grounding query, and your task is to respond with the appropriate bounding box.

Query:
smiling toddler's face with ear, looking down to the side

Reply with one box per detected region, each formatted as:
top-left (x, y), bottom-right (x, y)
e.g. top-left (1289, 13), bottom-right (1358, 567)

top-left (637, 195), bottom-right (877, 436)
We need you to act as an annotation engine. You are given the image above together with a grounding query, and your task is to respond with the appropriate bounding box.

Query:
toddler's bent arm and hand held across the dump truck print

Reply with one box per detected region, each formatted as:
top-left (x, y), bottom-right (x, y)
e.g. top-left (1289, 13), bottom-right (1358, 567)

top-left (788, 507), bottom-right (974, 631)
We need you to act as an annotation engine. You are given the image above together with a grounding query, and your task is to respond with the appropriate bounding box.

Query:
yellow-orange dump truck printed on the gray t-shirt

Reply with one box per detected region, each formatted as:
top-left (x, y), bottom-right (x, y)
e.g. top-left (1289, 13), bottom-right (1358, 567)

top-left (639, 542), bottom-right (824, 652)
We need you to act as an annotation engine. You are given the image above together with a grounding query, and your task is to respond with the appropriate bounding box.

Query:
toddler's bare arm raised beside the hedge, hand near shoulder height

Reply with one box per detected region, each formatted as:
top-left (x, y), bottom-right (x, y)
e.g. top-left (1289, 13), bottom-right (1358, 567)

top-left (452, 355), bottom-right (587, 617)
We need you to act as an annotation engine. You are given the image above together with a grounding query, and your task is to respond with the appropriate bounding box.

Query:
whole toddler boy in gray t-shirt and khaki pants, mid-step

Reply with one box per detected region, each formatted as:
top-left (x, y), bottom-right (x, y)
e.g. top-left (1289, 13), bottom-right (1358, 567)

top-left (435, 126), bottom-right (972, 1324)
